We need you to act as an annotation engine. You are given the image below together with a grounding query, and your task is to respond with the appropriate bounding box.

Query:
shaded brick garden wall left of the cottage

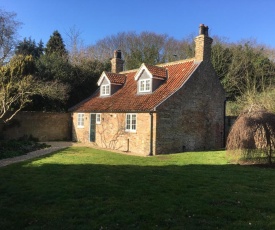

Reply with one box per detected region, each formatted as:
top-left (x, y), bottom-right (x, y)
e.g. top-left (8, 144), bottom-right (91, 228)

top-left (0, 112), bottom-right (72, 141)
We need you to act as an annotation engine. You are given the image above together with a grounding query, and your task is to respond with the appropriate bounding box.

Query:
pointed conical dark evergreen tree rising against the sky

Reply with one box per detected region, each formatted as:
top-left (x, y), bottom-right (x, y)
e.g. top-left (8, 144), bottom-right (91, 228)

top-left (45, 30), bottom-right (68, 56)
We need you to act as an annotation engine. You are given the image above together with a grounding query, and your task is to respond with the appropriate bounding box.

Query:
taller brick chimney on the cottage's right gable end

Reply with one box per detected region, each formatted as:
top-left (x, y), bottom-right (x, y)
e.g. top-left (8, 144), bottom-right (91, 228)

top-left (195, 24), bottom-right (213, 62)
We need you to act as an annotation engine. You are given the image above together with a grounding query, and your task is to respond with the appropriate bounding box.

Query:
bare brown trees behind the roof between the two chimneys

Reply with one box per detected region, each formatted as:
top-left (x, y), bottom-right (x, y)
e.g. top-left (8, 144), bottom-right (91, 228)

top-left (86, 32), bottom-right (194, 70)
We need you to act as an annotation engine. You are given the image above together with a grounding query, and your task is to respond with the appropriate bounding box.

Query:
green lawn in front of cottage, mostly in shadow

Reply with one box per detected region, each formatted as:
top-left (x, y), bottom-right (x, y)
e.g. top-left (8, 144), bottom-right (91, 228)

top-left (0, 147), bottom-right (275, 230)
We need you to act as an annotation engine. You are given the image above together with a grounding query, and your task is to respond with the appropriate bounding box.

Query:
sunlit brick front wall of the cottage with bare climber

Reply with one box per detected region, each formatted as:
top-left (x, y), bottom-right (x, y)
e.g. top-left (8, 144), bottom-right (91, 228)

top-left (73, 113), bottom-right (155, 155)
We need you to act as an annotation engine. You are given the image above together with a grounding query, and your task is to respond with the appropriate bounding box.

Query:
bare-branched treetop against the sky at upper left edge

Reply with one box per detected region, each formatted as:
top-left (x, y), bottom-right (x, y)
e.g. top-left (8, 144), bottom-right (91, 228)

top-left (0, 9), bottom-right (21, 66)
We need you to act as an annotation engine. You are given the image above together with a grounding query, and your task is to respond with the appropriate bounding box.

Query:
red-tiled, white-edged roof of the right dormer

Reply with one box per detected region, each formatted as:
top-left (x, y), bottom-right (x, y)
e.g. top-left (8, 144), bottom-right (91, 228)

top-left (134, 63), bottom-right (167, 81)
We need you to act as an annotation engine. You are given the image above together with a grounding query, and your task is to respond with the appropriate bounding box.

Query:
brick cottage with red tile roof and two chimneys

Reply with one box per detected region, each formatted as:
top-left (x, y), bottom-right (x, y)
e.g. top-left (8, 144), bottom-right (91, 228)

top-left (70, 24), bottom-right (225, 155)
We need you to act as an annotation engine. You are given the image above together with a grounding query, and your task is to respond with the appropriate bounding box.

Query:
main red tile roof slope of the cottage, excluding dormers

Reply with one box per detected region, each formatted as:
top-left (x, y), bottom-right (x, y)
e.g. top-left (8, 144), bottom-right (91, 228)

top-left (71, 59), bottom-right (200, 112)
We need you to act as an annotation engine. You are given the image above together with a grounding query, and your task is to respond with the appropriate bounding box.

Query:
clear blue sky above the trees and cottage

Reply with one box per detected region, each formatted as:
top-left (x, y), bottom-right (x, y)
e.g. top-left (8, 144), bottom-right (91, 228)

top-left (0, 0), bottom-right (275, 48)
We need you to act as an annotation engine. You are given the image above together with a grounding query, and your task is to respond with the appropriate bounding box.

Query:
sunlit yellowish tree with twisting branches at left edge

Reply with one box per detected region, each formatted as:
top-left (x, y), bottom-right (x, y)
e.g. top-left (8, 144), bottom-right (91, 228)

top-left (0, 55), bottom-right (68, 122)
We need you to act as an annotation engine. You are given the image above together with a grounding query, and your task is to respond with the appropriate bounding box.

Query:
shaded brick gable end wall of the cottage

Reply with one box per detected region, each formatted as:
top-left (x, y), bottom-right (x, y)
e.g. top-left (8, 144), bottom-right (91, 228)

top-left (156, 63), bottom-right (225, 154)
